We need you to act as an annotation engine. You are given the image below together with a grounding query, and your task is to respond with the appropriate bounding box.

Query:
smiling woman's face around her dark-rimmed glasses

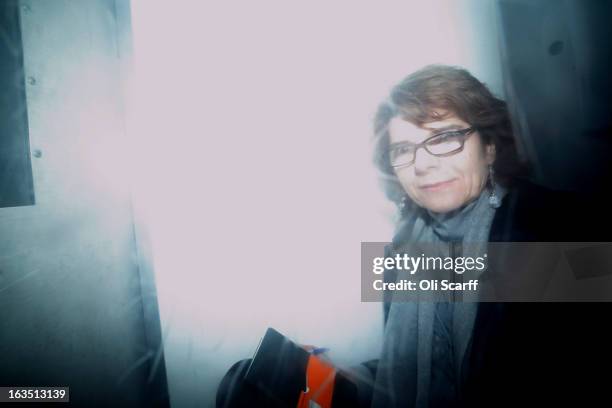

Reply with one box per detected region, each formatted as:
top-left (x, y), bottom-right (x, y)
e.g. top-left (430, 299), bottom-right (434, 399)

top-left (389, 115), bottom-right (495, 213)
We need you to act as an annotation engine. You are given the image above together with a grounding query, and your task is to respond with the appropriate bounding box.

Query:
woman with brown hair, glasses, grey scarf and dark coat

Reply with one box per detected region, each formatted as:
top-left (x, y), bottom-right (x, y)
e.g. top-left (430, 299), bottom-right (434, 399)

top-left (372, 65), bottom-right (610, 408)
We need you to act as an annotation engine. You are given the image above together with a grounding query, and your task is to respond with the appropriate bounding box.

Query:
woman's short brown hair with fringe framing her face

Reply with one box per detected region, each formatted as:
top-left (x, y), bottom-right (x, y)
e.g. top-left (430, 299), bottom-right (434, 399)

top-left (374, 65), bottom-right (529, 203)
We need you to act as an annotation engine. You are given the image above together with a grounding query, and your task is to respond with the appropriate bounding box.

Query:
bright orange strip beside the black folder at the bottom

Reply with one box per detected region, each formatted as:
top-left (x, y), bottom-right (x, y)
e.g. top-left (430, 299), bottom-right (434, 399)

top-left (297, 354), bottom-right (336, 408)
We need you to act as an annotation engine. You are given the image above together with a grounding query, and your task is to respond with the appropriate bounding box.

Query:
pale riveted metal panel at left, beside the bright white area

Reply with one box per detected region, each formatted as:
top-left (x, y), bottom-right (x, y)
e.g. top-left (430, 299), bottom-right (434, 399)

top-left (0, 0), bottom-right (168, 407)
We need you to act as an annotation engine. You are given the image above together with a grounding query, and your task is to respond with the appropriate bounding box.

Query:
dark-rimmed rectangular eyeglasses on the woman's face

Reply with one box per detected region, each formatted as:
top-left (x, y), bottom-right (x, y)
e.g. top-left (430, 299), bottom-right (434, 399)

top-left (389, 127), bottom-right (475, 168)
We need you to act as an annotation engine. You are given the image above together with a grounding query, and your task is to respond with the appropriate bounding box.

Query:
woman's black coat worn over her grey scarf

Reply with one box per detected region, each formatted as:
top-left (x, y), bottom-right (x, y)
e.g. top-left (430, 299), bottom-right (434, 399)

top-left (384, 182), bottom-right (612, 407)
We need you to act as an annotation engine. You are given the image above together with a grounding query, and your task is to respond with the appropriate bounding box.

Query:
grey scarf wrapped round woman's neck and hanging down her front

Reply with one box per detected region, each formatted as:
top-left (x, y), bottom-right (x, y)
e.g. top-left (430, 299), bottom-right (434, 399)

top-left (372, 184), bottom-right (506, 408)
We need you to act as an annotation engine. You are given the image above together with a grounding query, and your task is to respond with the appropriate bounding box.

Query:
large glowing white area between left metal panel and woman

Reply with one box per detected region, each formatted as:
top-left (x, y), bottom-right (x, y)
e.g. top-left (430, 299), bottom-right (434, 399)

top-left (129, 0), bottom-right (486, 406)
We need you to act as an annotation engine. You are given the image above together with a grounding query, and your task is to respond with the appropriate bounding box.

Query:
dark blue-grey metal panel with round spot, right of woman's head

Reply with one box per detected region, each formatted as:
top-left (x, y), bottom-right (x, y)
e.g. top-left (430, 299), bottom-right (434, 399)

top-left (498, 0), bottom-right (612, 193)
